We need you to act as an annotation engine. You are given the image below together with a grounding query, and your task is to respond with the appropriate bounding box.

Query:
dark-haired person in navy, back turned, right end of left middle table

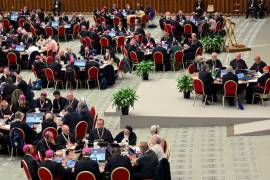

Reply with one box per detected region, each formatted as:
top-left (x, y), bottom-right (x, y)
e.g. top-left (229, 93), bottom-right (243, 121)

top-left (62, 105), bottom-right (81, 133)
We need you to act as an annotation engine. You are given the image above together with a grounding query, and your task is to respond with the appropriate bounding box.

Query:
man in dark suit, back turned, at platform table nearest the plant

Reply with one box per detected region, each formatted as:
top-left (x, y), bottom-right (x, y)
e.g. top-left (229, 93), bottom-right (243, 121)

top-left (199, 64), bottom-right (217, 105)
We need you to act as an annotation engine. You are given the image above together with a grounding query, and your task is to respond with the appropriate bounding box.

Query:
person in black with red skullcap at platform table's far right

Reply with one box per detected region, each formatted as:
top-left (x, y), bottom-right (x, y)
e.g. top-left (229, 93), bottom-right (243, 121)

top-left (246, 66), bottom-right (270, 104)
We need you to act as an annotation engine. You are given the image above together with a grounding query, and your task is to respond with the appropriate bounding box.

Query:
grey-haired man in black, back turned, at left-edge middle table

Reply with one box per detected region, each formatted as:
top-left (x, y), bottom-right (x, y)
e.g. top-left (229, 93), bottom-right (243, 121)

top-left (10, 111), bottom-right (36, 144)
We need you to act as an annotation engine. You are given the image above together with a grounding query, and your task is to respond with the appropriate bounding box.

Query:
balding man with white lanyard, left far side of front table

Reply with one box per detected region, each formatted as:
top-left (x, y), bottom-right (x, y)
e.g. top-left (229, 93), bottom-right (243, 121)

top-left (56, 125), bottom-right (75, 149)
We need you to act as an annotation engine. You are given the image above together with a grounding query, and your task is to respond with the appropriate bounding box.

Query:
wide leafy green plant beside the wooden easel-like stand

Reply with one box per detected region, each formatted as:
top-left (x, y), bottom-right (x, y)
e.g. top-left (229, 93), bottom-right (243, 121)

top-left (202, 35), bottom-right (224, 53)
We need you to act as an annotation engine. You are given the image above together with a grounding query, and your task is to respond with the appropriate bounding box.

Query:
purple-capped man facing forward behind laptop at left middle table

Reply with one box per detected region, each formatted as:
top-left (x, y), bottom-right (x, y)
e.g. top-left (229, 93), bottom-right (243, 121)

top-left (34, 91), bottom-right (52, 112)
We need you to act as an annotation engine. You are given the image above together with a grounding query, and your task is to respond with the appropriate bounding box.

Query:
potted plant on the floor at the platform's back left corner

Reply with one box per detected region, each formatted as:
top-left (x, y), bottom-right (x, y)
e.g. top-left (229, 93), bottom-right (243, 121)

top-left (136, 60), bottom-right (154, 80)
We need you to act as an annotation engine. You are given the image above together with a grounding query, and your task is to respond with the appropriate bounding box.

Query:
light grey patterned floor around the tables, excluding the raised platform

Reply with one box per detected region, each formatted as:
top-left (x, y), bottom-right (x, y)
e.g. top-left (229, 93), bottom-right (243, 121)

top-left (0, 18), bottom-right (270, 180)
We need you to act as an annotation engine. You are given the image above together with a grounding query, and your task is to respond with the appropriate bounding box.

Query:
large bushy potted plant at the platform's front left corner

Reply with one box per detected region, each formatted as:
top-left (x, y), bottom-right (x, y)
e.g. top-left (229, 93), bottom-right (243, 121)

top-left (113, 88), bottom-right (138, 115)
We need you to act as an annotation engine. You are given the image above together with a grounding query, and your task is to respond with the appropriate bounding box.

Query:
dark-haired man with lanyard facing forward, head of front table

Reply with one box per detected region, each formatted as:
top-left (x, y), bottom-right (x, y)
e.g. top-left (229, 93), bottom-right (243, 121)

top-left (88, 119), bottom-right (113, 143)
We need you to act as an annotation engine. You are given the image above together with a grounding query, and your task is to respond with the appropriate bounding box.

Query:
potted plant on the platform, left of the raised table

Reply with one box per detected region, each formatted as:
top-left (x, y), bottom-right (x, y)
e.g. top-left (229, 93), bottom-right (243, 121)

top-left (176, 74), bottom-right (193, 99)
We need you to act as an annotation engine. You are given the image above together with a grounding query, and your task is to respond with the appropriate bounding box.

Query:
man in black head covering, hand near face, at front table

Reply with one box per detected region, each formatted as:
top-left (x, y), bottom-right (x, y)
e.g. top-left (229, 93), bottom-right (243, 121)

top-left (114, 125), bottom-right (137, 146)
